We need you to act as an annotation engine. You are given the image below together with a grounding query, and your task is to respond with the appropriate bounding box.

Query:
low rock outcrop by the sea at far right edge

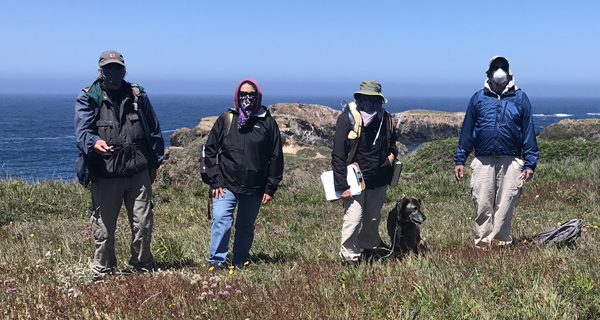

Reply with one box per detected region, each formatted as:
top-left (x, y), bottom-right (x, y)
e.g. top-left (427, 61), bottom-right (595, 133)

top-left (538, 119), bottom-right (600, 141)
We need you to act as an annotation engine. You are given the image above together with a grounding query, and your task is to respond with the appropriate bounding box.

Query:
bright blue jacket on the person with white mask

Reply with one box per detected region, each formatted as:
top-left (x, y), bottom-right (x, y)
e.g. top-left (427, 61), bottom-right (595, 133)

top-left (454, 87), bottom-right (540, 170)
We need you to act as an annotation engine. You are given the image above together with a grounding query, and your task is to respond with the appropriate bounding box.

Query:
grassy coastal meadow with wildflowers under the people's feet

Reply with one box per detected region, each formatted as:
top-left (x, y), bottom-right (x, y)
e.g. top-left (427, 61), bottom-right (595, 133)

top-left (0, 141), bottom-right (600, 319)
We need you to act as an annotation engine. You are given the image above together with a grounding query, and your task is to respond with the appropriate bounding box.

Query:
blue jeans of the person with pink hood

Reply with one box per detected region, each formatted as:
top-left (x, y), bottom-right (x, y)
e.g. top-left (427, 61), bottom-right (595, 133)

top-left (208, 189), bottom-right (262, 266)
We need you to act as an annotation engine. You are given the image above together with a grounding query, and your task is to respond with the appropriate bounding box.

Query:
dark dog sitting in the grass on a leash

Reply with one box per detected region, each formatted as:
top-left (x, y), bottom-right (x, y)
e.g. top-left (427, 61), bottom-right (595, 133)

top-left (387, 197), bottom-right (427, 254)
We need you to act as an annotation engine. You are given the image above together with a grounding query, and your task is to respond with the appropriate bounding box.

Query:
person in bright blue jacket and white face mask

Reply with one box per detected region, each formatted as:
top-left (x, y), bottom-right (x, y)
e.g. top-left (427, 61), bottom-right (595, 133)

top-left (454, 57), bottom-right (539, 248)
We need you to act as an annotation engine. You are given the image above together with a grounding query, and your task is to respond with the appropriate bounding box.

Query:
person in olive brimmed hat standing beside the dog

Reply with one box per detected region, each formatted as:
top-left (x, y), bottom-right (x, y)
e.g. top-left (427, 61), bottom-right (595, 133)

top-left (331, 80), bottom-right (398, 263)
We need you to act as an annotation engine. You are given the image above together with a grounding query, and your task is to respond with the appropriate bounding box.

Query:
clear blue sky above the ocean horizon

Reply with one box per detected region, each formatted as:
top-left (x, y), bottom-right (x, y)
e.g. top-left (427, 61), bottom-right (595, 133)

top-left (0, 0), bottom-right (600, 97)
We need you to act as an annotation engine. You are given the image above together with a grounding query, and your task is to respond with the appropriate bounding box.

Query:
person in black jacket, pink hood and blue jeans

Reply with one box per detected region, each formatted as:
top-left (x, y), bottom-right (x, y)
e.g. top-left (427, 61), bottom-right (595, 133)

top-left (205, 79), bottom-right (283, 269)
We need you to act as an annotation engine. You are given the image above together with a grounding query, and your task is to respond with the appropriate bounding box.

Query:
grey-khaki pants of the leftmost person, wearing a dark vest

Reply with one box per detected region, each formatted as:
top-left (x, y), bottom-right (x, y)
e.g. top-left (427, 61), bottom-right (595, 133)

top-left (90, 170), bottom-right (154, 274)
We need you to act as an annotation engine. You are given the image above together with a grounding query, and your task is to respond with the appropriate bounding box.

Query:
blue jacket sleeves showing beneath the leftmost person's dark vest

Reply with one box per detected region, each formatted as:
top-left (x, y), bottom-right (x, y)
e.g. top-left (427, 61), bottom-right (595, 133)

top-left (75, 80), bottom-right (164, 186)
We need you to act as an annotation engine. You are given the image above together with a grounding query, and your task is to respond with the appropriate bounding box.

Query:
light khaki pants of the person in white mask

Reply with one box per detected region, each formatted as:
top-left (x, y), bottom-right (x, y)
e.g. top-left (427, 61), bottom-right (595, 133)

top-left (471, 155), bottom-right (523, 246)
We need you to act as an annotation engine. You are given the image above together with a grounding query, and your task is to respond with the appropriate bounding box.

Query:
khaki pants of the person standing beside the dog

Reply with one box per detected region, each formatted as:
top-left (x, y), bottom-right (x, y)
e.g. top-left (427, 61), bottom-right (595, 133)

top-left (340, 186), bottom-right (387, 261)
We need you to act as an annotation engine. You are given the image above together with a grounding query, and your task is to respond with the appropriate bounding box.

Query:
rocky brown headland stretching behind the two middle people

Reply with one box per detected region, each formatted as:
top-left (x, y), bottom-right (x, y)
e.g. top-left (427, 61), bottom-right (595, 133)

top-left (158, 103), bottom-right (464, 184)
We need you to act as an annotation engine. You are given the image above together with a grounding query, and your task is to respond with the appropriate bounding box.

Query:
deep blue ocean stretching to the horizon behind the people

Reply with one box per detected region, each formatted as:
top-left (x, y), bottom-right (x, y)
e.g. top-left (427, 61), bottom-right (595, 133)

top-left (0, 93), bottom-right (600, 181)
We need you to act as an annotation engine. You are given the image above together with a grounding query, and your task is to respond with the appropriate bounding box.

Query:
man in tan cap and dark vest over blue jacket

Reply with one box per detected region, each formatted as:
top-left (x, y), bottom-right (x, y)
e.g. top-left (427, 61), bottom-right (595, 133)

top-left (75, 51), bottom-right (164, 280)
